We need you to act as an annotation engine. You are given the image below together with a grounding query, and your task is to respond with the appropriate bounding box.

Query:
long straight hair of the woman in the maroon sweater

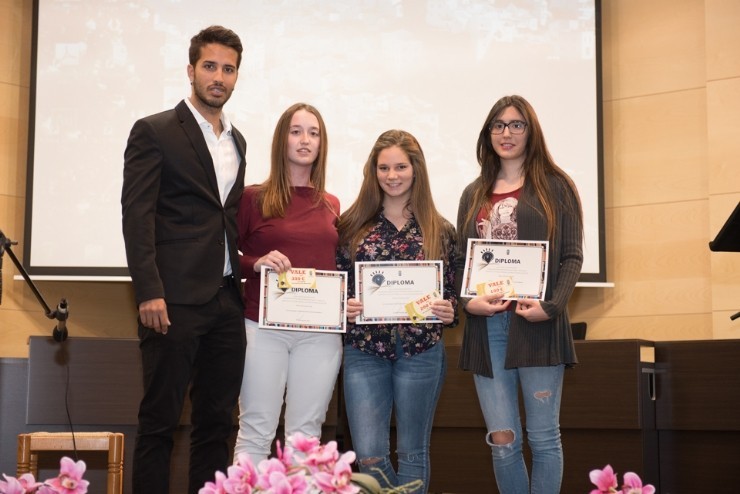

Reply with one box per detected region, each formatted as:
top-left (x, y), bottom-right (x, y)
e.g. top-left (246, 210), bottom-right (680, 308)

top-left (259, 103), bottom-right (336, 218)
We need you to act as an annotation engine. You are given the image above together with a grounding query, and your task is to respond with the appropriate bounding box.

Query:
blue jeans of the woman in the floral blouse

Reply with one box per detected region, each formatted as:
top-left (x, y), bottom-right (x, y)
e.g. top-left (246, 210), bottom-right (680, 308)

top-left (344, 340), bottom-right (447, 493)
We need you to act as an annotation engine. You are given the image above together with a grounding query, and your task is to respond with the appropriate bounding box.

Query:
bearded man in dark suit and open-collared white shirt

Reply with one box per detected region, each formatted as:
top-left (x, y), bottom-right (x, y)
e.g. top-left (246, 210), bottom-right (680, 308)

top-left (121, 26), bottom-right (247, 494)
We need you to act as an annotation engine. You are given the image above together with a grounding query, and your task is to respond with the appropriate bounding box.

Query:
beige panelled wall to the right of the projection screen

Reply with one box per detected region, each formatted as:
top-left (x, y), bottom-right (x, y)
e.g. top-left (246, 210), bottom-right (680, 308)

top-left (571, 0), bottom-right (740, 340)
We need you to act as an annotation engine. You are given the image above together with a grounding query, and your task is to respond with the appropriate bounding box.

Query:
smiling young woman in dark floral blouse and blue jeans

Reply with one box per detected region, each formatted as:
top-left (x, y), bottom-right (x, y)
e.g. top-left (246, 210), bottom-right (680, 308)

top-left (337, 130), bottom-right (457, 492)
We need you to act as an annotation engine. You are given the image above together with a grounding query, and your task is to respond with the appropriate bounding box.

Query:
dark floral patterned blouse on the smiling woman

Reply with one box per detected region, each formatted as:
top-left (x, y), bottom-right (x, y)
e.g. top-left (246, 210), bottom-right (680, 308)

top-left (337, 212), bottom-right (458, 359)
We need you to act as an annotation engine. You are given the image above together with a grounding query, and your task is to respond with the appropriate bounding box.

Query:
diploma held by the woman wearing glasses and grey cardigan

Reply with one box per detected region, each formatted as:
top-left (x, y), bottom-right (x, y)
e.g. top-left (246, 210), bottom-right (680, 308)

top-left (460, 238), bottom-right (550, 300)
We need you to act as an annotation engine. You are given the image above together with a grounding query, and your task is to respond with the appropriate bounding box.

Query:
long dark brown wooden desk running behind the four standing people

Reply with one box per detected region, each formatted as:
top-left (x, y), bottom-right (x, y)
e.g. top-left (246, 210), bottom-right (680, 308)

top-left (23, 337), bottom-right (740, 494)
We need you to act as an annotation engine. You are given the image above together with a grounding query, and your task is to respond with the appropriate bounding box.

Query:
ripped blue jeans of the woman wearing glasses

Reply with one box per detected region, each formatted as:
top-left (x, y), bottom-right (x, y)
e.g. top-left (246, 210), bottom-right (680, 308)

top-left (474, 312), bottom-right (565, 494)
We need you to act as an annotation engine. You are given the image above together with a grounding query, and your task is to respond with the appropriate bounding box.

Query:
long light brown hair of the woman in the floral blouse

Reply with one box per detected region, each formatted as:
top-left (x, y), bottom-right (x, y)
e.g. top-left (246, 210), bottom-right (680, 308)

top-left (337, 130), bottom-right (454, 261)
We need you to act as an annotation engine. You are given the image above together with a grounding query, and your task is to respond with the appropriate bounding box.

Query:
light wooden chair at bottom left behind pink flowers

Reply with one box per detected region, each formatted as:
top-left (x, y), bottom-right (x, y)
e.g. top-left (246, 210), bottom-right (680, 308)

top-left (17, 432), bottom-right (123, 494)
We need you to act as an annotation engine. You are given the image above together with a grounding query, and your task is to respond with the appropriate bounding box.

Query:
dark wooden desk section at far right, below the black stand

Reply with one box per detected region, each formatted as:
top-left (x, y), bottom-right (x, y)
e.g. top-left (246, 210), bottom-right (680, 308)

top-left (655, 340), bottom-right (740, 494)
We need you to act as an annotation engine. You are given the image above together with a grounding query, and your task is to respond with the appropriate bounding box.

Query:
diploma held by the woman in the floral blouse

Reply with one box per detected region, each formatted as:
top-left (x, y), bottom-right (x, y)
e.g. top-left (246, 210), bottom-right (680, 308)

top-left (355, 261), bottom-right (443, 324)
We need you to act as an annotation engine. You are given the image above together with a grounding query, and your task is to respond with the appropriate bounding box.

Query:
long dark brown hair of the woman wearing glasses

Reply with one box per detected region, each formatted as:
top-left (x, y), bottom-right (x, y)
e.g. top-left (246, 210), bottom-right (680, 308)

top-left (465, 95), bottom-right (583, 242)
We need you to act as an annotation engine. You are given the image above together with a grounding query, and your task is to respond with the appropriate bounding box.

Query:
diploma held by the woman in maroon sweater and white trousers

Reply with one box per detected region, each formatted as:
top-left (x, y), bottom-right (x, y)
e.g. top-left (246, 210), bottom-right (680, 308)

top-left (258, 266), bottom-right (347, 333)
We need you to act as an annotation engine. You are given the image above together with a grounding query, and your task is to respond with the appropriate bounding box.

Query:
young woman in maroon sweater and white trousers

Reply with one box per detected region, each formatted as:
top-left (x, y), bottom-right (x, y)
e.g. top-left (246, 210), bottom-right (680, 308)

top-left (235, 103), bottom-right (342, 464)
